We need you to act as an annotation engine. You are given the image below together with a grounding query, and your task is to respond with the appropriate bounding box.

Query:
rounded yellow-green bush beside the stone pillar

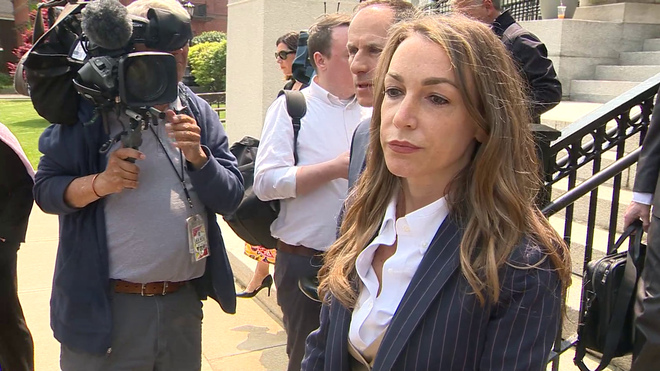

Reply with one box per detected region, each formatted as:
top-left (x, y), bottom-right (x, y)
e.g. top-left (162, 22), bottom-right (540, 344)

top-left (188, 40), bottom-right (227, 91)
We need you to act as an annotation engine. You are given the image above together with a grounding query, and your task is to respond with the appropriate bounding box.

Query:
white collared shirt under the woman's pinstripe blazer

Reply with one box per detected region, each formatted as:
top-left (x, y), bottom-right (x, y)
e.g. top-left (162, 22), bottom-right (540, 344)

top-left (348, 196), bottom-right (449, 359)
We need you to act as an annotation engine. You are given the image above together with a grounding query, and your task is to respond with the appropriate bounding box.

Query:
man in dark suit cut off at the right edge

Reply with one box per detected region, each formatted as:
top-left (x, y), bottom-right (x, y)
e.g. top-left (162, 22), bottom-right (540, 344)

top-left (624, 91), bottom-right (660, 371)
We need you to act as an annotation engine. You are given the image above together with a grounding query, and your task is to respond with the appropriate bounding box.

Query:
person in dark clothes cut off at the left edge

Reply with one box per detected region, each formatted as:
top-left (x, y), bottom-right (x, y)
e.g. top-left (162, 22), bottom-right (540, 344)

top-left (0, 124), bottom-right (34, 371)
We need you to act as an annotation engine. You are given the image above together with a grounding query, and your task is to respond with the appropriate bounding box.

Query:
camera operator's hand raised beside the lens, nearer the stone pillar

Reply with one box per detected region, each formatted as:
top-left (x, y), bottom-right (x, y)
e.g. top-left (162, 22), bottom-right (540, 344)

top-left (165, 110), bottom-right (208, 169)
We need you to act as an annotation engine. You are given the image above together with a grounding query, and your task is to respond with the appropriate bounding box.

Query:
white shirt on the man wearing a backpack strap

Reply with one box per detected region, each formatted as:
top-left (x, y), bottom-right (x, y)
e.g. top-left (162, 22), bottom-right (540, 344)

top-left (254, 81), bottom-right (371, 251)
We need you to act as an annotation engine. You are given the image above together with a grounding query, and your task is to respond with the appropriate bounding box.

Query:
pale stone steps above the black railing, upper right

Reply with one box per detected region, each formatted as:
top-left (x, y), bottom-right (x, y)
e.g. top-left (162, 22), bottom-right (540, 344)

top-left (570, 38), bottom-right (660, 103)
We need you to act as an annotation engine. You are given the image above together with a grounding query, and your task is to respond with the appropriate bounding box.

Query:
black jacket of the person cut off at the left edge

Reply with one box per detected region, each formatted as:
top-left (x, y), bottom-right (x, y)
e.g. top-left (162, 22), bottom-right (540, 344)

top-left (0, 141), bottom-right (34, 246)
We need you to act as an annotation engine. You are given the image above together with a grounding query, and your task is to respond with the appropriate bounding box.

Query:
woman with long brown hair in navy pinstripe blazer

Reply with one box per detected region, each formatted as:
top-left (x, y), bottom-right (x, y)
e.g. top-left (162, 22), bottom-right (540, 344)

top-left (302, 16), bottom-right (570, 371)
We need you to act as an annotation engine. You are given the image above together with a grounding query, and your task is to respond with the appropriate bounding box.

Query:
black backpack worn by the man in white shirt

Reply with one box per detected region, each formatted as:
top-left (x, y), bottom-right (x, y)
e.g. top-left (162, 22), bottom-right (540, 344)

top-left (224, 90), bottom-right (307, 249)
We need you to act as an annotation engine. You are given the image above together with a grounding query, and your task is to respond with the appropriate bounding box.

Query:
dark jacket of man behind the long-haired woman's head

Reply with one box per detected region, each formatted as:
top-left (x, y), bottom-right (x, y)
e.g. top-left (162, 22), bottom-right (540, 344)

top-left (492, 11), bottom-right (561, 124)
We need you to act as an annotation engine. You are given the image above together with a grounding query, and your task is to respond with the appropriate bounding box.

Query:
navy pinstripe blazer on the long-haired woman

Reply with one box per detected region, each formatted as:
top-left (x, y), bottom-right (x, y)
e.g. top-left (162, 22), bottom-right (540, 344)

top-left (302, 218), bottom-right (561, 371)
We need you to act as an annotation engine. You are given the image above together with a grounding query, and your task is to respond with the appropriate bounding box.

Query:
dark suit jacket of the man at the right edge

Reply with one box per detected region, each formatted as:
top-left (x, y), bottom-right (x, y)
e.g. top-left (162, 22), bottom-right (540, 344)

top-left (633, 91), bottom-right (660, 218)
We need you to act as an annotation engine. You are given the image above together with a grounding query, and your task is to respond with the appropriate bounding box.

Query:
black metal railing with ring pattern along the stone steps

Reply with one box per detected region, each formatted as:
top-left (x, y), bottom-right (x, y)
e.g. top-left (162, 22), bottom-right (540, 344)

top-left (541, 74), bottom-right (660, 371)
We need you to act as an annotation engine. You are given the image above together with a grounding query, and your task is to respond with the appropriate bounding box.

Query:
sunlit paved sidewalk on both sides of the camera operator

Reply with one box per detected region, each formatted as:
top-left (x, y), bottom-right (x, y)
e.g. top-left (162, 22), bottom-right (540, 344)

top-left (18, 205), bottom-right (287, 371)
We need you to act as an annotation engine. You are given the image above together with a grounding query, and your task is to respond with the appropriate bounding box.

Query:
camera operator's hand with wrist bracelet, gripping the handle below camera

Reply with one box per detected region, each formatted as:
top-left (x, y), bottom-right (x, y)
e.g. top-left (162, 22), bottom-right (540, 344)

top-left (93, 148), bottom-right (145, 197)
